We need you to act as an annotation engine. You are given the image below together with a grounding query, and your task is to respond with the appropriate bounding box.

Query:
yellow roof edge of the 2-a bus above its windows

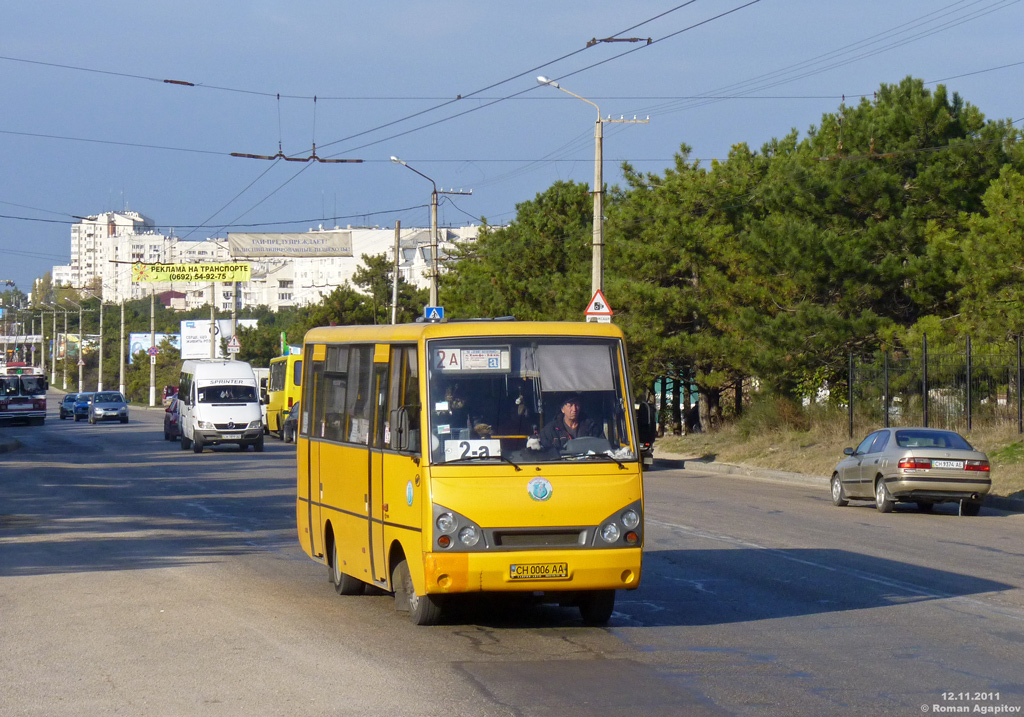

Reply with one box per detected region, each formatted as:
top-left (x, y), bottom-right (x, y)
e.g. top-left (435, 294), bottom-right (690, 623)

top-left (305, 321), bottom-right (623, 343)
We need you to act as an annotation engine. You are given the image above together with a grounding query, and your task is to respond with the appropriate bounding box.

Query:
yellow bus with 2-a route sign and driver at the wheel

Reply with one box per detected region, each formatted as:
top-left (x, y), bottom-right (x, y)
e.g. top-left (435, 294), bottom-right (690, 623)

top-left (296, 320), bottom-right (652, 625)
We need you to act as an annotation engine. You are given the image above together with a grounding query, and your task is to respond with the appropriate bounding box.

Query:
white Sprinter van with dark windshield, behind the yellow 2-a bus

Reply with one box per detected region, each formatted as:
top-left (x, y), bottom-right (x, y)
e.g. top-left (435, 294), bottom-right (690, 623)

top-left (178, 359), bottom-right (263, 453)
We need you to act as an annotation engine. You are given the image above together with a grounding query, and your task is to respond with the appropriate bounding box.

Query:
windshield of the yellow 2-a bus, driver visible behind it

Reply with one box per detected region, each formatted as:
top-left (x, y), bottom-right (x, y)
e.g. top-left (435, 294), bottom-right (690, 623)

top-left (427, 337), bottom-right (636, 464)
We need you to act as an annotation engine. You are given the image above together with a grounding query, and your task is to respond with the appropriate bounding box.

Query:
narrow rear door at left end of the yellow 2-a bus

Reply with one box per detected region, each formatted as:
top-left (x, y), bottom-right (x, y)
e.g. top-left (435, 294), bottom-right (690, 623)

top-left (298, 344), bottom-right (327, 557)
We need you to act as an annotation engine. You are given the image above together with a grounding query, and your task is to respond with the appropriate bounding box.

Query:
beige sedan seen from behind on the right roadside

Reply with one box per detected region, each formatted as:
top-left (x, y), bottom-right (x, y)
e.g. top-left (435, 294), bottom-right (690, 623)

top-left (830, 428), bottom-right (992, 515)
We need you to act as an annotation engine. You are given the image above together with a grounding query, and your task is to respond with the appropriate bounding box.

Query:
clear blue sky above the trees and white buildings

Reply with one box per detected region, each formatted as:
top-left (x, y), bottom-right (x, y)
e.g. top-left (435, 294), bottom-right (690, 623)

top-left (0, 0), bottom-right (1024, 291)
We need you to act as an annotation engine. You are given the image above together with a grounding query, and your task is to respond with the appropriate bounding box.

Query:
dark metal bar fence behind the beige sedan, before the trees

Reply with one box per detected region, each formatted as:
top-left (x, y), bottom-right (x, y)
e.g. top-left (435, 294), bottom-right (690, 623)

top-left (849, 336), bottom-right (1024, 437)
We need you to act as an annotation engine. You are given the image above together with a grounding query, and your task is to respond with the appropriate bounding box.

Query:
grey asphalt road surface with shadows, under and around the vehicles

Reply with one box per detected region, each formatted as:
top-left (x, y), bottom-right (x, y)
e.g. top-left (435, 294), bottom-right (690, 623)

top-left (0, 410), bottom-right (1024, 717)
